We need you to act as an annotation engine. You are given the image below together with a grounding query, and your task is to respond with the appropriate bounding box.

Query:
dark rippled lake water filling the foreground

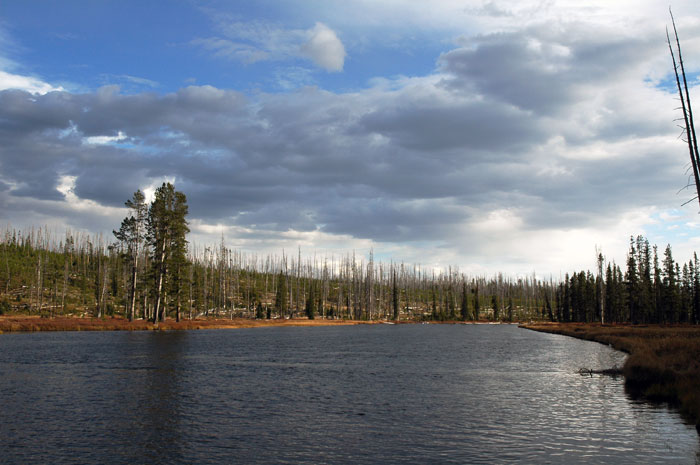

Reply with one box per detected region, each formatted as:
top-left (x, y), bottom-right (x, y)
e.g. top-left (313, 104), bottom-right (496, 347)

top-left (0, 325), bottom-right (700, 464)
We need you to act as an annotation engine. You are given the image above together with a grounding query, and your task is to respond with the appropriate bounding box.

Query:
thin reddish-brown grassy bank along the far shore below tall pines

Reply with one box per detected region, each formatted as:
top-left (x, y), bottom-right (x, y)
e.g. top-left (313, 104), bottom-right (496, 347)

top-left (0, 316), bottom-right (378, 332)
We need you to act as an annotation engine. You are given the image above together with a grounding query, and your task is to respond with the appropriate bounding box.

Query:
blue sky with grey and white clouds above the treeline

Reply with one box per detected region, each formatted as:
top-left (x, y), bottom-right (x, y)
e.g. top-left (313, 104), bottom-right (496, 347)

top-left (0, 0), bottom-right (700, 279)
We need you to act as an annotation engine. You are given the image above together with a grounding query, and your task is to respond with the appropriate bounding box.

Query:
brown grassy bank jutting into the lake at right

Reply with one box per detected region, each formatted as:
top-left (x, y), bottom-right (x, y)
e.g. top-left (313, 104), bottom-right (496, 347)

top-left (523, 323), bottom-right (700, 431)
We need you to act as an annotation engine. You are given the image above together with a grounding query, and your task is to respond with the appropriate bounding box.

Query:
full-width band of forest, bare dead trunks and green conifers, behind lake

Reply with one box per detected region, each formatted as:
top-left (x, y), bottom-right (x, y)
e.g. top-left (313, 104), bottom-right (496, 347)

top-left (0, 194), bottom-right (700, 323)
